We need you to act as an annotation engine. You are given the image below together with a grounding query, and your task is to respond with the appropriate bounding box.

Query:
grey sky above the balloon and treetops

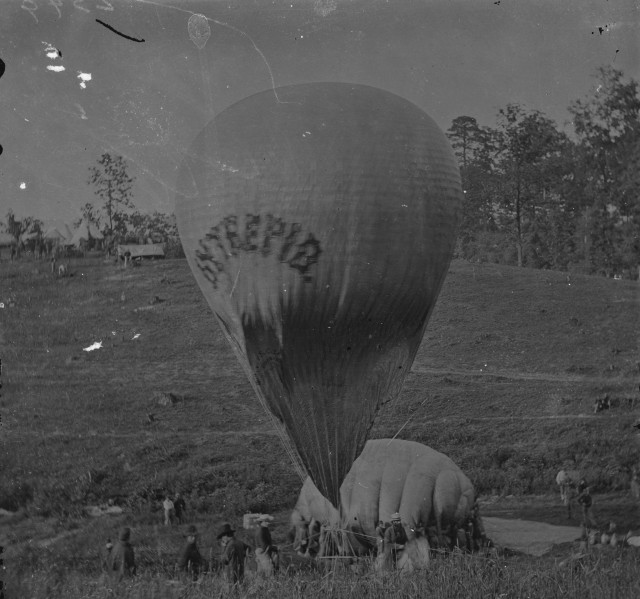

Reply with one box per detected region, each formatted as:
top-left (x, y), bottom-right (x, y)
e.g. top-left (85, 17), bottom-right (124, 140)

top-left (0, 0), bottom-right (640, 224)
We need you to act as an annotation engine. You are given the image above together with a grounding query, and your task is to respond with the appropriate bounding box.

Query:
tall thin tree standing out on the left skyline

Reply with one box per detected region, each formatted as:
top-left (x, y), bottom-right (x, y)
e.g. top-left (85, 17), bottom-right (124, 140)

top-left (85, 152), bottom-right (135, 235)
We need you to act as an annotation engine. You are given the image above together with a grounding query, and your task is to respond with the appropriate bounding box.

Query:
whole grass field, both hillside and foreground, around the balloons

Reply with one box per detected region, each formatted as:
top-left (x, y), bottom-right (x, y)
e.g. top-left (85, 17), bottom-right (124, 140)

top-left (0, 259), bottom-right (640, 597)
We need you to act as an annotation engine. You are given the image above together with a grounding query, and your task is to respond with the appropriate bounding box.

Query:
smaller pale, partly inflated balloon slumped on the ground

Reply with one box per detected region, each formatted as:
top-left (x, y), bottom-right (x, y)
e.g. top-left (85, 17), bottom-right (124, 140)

top-left (291, 439), bottom-right (475, 553)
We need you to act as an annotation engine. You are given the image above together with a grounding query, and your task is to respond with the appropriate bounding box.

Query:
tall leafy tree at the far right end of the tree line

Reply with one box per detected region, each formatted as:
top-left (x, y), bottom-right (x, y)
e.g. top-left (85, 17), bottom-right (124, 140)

top-left (569, 67), bottom-right (640, 274)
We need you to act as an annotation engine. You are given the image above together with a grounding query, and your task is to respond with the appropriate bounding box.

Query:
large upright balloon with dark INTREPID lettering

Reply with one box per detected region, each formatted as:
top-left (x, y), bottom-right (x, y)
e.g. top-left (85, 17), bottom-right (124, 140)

top-left (176, 83), bottom-right (462, 505)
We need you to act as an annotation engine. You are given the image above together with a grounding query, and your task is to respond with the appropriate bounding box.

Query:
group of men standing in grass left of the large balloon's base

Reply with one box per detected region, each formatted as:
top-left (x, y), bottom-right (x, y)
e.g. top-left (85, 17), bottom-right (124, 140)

top-left (102, 512), bottom-right (279, 584)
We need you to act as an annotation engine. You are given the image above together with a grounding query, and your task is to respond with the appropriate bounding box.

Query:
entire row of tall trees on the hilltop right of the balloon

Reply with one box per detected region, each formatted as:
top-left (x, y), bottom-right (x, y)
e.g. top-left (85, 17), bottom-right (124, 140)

top-left (447, 67), bottom-right (640, 279)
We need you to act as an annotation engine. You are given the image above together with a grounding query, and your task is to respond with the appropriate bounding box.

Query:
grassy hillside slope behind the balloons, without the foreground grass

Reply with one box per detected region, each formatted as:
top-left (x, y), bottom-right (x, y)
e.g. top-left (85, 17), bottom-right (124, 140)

top-left (0, 260), bottom-right (640, 511)
